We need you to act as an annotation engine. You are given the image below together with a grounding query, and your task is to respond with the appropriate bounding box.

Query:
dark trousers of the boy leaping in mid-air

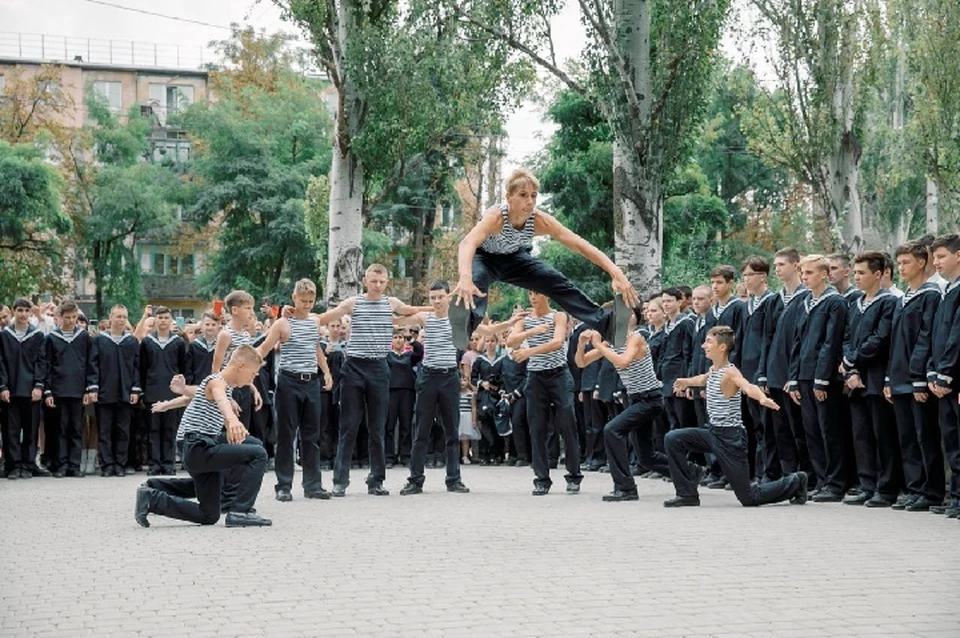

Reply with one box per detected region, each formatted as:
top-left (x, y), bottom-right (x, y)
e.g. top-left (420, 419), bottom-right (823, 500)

top-left (470, 249), bottom-right (610, 336)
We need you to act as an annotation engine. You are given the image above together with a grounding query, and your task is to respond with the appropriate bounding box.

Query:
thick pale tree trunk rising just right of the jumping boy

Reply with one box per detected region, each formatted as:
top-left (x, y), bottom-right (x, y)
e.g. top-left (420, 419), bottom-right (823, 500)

top-left (613, 0), bottom-right (663, 296)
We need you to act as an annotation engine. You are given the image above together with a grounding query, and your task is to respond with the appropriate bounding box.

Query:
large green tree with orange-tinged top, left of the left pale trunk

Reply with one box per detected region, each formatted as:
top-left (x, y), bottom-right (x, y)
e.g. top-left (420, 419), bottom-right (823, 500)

top-left (183, 30), bottom-right (331, 298)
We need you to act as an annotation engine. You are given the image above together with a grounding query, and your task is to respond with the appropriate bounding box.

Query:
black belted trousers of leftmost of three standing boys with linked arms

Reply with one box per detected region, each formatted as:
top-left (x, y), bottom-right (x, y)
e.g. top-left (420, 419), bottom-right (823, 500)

top-left (273, 371), bottom-right (321, 492)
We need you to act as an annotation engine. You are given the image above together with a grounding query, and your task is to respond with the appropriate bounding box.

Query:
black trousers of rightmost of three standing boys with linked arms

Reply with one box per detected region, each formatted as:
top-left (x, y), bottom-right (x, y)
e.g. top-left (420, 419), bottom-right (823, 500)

top-left (410, 367), bottom-right (460, 486)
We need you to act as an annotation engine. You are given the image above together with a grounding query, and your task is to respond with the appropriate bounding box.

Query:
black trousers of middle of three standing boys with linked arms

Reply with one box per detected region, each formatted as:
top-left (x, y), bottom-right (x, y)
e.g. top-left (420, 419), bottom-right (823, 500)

top-left (333, 357), bottom-right (390, 487)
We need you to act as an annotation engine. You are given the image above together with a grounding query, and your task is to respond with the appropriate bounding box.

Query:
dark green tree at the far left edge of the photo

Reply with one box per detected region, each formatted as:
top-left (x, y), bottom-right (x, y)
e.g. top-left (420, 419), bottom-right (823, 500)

top-left (0, 141), bottom-right (71, 300)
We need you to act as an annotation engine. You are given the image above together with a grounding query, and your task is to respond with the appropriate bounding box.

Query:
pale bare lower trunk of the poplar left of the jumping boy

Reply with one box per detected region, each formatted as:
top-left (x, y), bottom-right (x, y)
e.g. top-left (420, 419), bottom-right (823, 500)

top-left (327, 144), bottom-right (363, 303)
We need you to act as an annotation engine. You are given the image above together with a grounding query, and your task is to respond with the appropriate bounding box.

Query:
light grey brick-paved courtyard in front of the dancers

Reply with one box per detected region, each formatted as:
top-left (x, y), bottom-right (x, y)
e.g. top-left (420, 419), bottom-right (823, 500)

top-left (0, 466), bottom-right (960, 638)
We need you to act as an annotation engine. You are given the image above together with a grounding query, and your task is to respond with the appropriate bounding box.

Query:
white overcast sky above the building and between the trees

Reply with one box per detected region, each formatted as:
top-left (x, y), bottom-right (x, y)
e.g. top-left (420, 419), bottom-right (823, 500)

top-left (0, 0), bottom-right (760, 174)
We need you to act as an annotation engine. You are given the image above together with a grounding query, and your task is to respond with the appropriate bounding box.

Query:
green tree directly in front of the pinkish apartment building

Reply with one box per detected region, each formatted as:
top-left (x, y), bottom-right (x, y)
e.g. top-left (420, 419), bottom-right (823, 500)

top-left (65, 92), bottom-right (178, 317)
